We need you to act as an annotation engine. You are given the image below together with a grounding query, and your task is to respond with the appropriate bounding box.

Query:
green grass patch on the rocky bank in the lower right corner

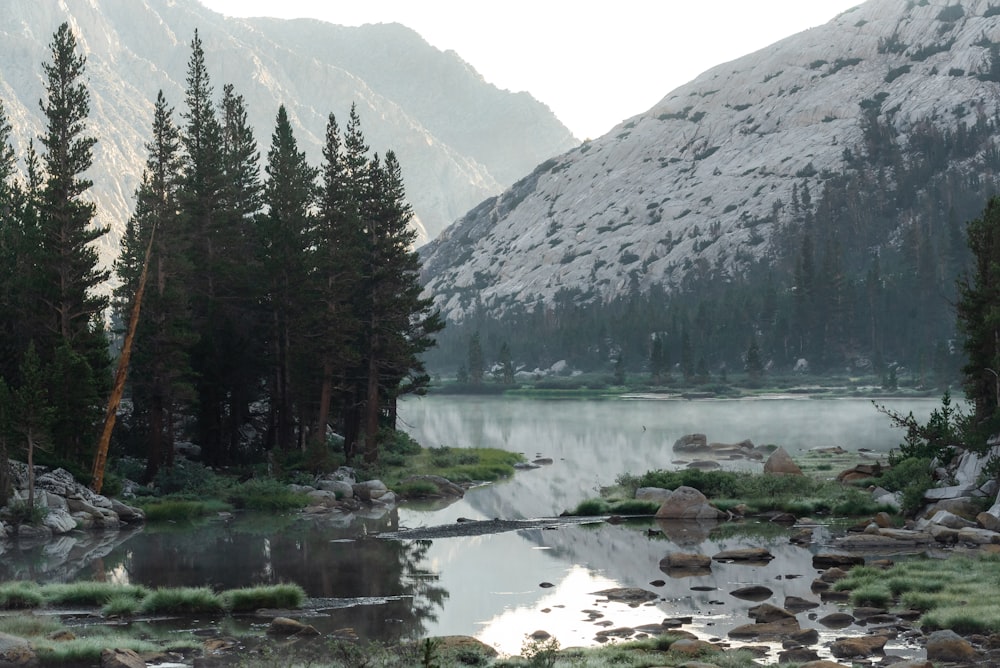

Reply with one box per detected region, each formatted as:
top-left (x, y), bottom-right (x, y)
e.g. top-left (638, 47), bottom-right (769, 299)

top-left (834, 555), bottom-right (1000, 634)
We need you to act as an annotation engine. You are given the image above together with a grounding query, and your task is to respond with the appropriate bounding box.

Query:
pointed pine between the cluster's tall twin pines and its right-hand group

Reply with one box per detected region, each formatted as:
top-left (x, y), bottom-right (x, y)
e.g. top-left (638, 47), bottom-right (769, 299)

top-left (262, 105), bottom-right (317, 449)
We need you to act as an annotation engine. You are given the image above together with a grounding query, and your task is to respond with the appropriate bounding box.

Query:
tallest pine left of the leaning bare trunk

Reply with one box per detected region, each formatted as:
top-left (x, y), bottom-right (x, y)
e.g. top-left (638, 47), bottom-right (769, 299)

top-left (35, 23), bottom-right (110, 461)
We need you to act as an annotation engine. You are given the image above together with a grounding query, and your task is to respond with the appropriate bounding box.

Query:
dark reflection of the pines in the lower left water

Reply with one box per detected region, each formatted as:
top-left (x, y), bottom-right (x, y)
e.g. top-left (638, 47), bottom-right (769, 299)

top-left (3, 511), bottom-right (448, 640)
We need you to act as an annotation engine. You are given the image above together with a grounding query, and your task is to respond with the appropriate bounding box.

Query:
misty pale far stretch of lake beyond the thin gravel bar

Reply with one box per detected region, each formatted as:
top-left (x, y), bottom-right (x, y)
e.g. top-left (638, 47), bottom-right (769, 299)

top-left (400, 397), bottom-right (936, 519)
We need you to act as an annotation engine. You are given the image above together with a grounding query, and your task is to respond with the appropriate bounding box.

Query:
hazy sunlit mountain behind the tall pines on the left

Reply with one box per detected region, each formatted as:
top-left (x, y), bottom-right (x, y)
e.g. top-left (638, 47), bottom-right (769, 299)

top-left (0, 0), bottom-right (577, 261)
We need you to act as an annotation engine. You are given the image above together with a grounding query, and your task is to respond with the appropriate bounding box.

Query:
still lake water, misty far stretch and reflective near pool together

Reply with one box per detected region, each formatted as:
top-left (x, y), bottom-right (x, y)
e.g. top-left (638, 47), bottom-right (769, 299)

top-left (0, 397), bottom-right (938, 653)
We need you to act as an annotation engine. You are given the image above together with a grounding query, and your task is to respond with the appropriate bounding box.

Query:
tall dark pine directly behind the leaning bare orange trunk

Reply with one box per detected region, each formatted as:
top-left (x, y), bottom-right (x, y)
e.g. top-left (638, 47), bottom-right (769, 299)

top-left (114, 91), bottom-right (194, 480)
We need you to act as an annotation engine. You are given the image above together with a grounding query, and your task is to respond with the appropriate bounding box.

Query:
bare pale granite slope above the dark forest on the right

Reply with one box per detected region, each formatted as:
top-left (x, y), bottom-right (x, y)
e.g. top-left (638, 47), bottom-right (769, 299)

top-left (422, 0), bottom-right (1000, 321)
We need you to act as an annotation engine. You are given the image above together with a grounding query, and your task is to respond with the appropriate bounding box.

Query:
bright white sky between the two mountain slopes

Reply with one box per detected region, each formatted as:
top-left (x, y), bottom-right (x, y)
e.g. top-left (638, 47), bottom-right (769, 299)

top-left (202, 0), bottom-right (861, 139)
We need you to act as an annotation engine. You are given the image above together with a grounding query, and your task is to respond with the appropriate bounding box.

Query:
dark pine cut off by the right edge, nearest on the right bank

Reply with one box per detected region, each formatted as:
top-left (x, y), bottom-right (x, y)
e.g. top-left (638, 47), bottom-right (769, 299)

top-left (956, 197), bottom-right (1000, 433)
